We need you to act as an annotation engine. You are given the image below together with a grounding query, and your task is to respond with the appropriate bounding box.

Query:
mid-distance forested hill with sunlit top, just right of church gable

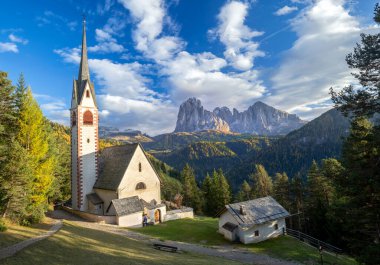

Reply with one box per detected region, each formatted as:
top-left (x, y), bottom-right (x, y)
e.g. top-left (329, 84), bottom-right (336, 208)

top-left (154, 136), bottom-right (270, 180)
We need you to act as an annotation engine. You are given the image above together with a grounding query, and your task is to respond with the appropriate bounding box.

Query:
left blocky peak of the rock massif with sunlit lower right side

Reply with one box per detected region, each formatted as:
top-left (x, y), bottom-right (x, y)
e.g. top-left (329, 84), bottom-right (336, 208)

top-left (175, 98), bottom-right (230, 132)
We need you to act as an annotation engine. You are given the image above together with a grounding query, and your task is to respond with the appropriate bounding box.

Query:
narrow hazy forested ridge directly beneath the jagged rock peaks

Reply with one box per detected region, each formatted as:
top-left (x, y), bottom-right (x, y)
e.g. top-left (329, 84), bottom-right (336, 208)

top-left (142, 130), bottom-right (262, 150)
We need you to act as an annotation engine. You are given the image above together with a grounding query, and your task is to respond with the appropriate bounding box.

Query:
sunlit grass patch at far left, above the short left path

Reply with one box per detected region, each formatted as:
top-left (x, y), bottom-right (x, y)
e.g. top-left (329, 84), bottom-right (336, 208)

top-left (0, 219), bottom-right (52, 248)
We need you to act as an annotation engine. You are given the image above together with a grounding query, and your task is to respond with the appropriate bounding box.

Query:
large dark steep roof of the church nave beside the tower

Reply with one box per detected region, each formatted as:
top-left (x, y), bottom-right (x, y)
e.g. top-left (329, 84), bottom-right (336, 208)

top-left (94, 144), bottom-right (139, 190)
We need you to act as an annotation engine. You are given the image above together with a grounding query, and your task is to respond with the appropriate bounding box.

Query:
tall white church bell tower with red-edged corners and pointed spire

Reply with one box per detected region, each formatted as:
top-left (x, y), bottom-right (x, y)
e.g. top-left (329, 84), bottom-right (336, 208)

top-left (70, 20), bottom-right (99, 211)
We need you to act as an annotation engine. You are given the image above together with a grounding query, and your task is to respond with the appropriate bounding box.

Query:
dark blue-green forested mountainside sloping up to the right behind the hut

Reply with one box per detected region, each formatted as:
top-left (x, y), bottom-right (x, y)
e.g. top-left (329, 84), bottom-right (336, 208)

top-left (228, 109), bottom-right (350, 186)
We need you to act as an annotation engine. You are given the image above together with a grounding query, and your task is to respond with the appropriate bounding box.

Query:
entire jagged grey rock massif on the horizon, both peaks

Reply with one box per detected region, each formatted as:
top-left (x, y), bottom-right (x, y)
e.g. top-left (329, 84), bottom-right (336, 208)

top-left (175, 98), bottom-right (306, 135)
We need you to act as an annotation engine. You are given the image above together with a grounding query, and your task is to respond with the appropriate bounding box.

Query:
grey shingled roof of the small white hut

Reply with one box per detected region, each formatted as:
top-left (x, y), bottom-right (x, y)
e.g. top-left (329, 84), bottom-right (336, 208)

top-left (226, 196), bottom-right (289, 227)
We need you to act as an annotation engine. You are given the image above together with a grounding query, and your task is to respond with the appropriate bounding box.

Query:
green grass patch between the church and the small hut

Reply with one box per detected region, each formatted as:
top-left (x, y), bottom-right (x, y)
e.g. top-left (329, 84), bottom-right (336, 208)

top-left (132, 217), bottom-right (229, 245)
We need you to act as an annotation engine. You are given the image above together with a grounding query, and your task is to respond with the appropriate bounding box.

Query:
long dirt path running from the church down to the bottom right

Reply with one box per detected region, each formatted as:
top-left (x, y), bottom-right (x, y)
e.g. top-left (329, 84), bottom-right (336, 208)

top-left (50, 210), bottom-right (299, 265)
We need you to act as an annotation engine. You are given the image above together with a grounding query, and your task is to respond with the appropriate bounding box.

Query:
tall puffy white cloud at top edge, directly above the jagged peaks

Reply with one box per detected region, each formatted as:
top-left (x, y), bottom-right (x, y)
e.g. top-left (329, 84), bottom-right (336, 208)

top-left (211, 1), bottom-right (264, 70)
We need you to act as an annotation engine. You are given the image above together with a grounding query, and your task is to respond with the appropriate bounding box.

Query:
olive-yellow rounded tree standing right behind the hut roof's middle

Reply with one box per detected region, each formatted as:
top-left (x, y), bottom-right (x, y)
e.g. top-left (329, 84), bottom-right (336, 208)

top-left (251, 164), bottom-right (273, 198)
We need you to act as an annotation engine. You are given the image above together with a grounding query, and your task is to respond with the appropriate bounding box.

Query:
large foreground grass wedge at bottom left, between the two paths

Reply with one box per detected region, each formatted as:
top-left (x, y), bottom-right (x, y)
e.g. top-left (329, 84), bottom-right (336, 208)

top-left (0, 221), bottom-right (241, 265)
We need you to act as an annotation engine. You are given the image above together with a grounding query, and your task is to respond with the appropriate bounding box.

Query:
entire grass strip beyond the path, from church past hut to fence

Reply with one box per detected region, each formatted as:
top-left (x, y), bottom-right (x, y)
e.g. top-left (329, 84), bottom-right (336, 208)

top-left (135, 217), bottom-right (357, 265)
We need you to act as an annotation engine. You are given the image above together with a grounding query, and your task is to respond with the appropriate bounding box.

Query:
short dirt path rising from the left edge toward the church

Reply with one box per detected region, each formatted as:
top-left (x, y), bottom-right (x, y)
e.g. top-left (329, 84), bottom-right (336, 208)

top-left (0, 220), bottom-right (62, 260)
